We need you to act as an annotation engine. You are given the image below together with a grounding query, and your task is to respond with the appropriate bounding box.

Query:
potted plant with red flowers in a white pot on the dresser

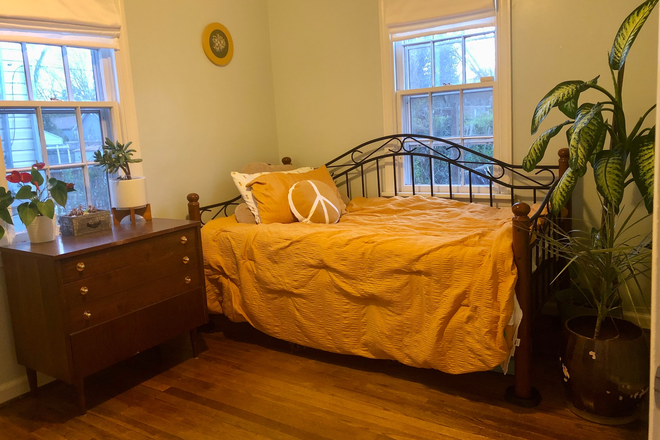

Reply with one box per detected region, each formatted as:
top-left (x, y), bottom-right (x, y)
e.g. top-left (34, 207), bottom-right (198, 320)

top-left (0, 162), bottom-right (75, 243)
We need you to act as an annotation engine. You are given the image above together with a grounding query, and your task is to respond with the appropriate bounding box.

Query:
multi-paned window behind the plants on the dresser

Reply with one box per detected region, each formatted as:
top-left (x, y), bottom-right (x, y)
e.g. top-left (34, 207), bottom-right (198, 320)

top-left (0, 42), bottom-right (118, 232)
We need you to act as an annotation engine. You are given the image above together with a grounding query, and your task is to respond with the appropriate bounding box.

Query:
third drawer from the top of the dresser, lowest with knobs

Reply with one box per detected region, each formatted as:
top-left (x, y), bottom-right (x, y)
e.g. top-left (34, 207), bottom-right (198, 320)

top-left (66, 268), bottom-right (202, 333)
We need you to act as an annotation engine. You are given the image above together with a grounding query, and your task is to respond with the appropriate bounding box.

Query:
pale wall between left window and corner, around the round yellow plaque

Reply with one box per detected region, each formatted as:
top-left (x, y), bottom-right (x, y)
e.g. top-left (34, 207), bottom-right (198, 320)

top-left (125, 0), bottom-right (278, 218)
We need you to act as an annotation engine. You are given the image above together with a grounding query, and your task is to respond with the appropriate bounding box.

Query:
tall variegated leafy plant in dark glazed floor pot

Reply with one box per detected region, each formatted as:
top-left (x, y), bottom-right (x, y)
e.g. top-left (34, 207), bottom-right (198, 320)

top-left (523, 0), bottom-right (658, 423)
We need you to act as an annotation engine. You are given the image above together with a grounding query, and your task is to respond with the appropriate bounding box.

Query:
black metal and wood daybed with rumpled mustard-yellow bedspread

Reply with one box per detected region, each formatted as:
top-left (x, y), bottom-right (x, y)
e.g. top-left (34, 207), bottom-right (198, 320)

top-left (188, 135), bottom-right (567, 406)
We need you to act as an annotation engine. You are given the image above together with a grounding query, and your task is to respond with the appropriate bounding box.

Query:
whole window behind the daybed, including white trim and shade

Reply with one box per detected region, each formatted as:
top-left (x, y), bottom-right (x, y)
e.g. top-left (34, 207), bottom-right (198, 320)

top-left (379, 0), bottom-right (513, 197)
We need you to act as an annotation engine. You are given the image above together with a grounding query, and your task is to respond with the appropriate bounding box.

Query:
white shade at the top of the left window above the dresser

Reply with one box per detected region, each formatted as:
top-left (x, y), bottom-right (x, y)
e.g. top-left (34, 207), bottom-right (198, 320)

top-left (0, 0), bottom-right (121, 47)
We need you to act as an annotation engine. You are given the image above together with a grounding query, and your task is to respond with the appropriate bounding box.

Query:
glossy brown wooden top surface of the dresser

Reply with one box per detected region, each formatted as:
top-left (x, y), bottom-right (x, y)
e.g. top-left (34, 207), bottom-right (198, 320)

top-left (0, 218), bottom-right (200, 258)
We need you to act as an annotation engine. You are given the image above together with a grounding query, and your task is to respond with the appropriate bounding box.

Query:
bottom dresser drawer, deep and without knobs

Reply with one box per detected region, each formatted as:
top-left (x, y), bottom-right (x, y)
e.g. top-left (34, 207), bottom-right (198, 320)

top-left (70, 287), bottom-right (207, 377)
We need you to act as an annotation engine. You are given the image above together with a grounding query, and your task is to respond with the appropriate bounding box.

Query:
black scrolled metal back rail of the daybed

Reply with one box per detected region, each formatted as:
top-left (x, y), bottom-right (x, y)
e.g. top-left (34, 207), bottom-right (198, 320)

top-left (189, 134), bottom-right (560, 223)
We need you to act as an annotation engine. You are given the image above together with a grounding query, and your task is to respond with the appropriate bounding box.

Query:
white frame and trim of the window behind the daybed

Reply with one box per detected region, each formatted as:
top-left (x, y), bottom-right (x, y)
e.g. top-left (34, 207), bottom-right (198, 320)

top-left (379, 0), bottom-right (513, 198)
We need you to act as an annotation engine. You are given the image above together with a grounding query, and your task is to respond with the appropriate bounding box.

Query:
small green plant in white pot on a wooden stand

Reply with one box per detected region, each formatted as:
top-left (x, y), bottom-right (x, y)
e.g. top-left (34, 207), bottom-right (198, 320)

top-left (94, 138), bottom-right (147, 209)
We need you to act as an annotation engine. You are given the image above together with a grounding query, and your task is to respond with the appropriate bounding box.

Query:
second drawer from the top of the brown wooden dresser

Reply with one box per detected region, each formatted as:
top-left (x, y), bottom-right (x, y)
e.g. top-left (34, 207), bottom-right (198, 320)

top-left (63, 248), bottom-right (201, 308)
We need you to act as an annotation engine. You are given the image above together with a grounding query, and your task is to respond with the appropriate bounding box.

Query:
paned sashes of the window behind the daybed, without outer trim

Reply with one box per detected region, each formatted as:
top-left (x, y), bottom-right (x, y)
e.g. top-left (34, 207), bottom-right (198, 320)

top-left (394, 26), bottom-right (496, 190)
